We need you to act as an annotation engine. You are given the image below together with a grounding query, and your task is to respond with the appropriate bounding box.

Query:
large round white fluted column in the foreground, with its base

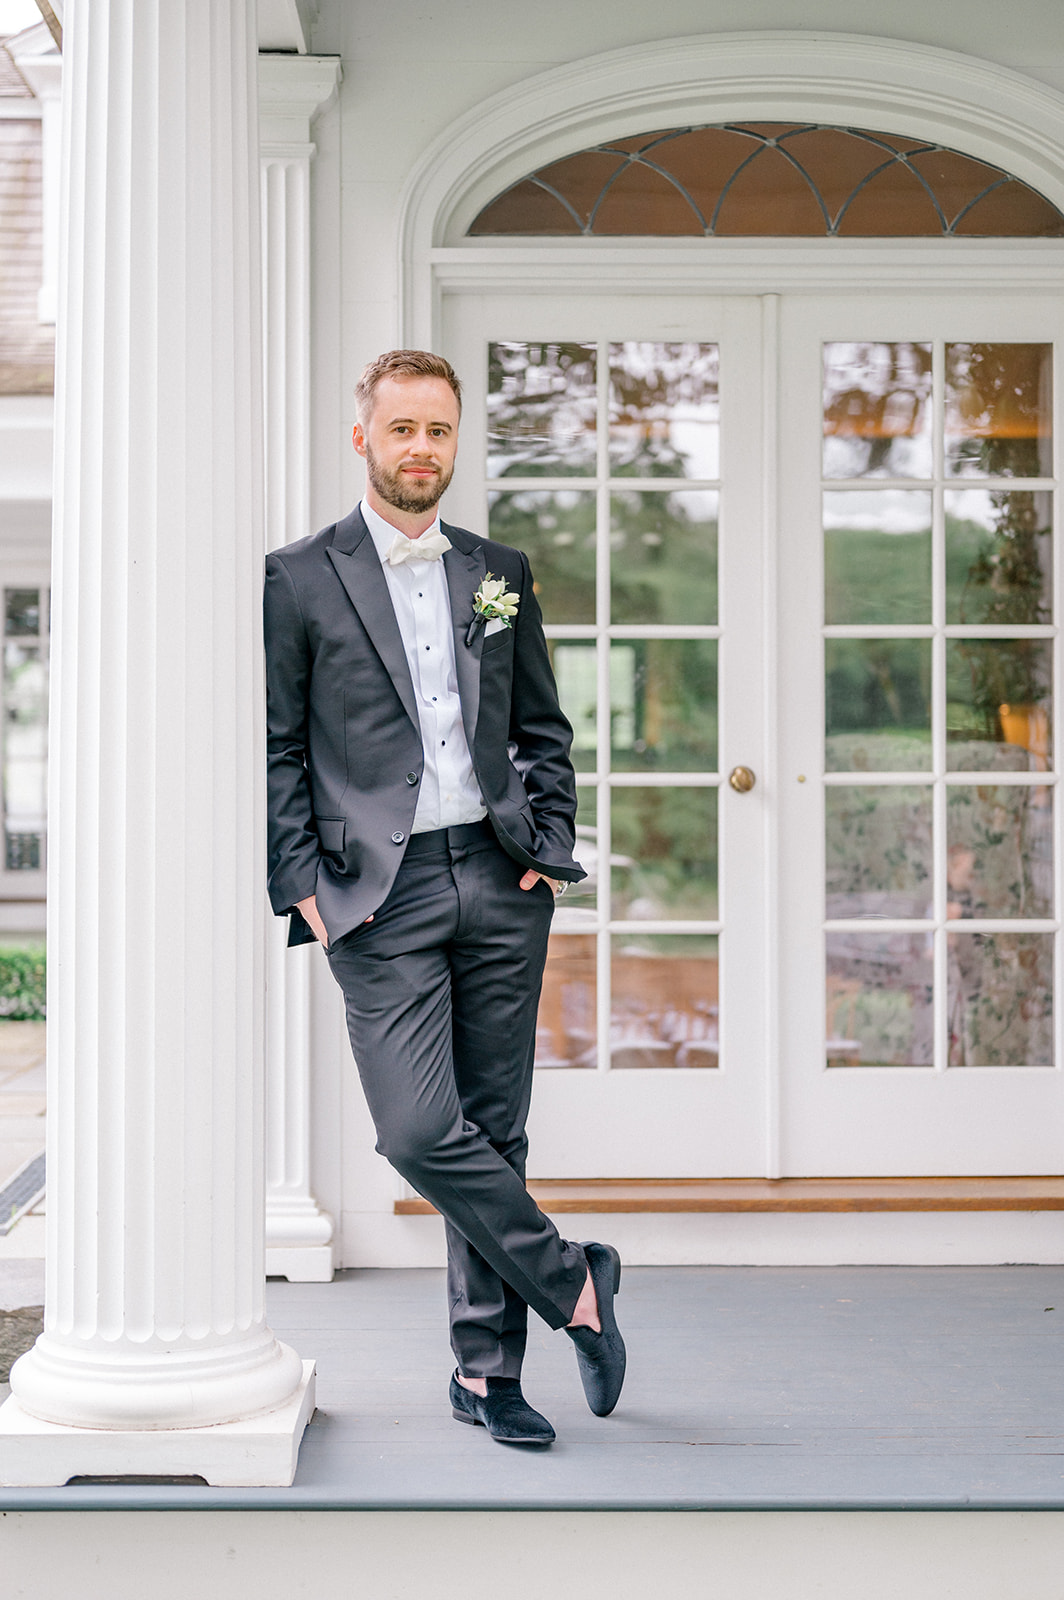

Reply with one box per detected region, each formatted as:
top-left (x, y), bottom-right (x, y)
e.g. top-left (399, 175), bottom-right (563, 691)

top-left (0, 0), bottom-right (312, 1483)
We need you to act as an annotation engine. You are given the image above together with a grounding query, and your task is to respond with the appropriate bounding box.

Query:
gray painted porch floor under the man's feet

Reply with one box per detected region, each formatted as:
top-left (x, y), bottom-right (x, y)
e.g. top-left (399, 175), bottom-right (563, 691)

top-left (0, 1267), bottom-right (1064, 1510)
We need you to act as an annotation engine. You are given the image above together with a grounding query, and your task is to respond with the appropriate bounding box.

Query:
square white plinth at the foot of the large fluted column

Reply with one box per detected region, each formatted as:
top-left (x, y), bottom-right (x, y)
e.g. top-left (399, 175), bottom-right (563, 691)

top-left (0, 1362), bottom-right (314, 1488)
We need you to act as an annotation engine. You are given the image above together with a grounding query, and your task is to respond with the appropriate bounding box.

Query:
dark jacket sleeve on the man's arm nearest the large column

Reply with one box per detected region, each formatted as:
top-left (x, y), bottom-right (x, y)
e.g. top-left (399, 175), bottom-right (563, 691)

top-left (264, 555), bottom-right (322, 917)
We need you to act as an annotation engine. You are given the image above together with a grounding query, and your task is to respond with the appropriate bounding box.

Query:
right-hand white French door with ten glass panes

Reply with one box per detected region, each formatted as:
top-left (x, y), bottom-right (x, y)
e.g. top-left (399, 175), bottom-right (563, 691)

top-left (778, 293), bottom-right (1064, 1174)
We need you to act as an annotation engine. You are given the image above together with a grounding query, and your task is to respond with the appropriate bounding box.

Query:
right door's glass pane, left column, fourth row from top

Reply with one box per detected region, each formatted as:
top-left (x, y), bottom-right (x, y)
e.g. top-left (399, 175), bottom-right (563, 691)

top-left (824, 784), bottom-right (934, 920)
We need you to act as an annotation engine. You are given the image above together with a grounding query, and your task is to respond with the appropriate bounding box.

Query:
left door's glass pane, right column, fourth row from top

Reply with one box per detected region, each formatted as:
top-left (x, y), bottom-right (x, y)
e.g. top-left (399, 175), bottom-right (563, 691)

top-left (610, 786), bottom-right (717, 922)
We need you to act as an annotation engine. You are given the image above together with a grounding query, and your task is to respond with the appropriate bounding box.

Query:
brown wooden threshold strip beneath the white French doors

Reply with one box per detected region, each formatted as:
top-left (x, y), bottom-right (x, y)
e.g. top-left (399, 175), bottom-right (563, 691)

top-left (395, 1178), bottom-right (1064, 1216)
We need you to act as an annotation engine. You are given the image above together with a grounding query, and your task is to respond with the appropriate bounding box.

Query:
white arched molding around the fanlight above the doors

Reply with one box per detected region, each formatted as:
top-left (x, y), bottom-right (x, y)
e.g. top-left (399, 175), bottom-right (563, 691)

top-left (400, 32), bottom-right (1064, 342)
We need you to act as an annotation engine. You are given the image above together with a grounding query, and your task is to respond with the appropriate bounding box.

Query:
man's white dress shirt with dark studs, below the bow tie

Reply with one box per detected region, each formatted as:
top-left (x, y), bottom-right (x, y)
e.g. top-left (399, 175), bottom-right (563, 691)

top-left (360, 499), bottom-right (488, 834)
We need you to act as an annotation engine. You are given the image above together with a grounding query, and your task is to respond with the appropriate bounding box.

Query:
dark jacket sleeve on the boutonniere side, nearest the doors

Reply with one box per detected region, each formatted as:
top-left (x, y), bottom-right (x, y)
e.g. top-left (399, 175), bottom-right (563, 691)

top-left (510, 552), bottom-right (587, 883)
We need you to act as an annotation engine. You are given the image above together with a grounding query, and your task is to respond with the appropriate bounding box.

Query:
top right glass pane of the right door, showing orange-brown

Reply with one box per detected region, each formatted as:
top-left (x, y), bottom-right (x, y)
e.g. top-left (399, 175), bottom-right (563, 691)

top-left (946, 344), bottom-right (1053, 478)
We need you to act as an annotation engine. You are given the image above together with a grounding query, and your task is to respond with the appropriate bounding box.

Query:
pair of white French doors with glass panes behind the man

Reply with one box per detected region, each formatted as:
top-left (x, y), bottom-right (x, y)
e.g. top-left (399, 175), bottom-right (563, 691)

top-left (442, 278), bottom-right (1064, 1178)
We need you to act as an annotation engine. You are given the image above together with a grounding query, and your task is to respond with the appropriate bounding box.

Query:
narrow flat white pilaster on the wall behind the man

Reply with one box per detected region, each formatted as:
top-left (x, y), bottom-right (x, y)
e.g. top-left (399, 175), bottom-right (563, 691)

top-left (259, 56), bottom-right (339, 1283)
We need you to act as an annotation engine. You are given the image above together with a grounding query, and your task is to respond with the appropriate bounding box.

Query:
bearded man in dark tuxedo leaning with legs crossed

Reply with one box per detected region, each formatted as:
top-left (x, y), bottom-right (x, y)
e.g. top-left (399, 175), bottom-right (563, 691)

top-left (266, 350), bottom-right (624, 1445)
